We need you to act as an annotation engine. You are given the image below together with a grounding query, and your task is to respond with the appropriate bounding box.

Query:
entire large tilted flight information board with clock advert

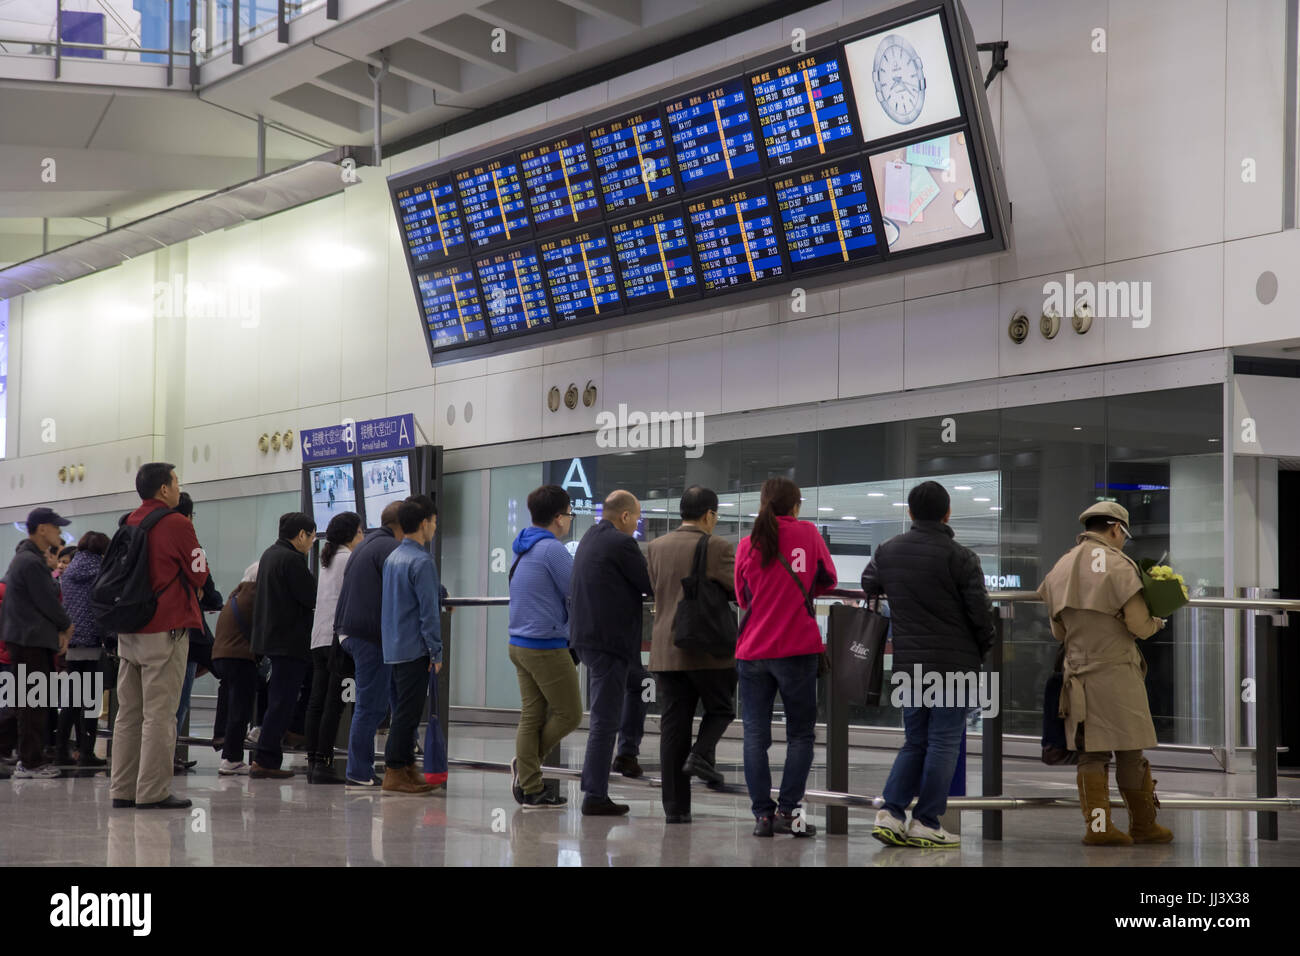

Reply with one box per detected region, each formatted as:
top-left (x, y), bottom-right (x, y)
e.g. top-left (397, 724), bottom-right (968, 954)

top-left (389, 0), bottom-right (1010, 364)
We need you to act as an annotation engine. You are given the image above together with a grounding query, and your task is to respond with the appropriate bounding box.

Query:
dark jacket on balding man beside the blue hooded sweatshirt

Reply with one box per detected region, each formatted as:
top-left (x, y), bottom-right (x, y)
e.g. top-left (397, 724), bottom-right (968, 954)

top-left (569, 519), bottom-right (654, 659)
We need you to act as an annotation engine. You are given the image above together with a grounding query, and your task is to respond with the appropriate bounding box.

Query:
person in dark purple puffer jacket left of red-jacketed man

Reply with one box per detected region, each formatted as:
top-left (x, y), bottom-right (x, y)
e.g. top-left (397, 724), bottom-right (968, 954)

top-left (56, 531), bottom-right (111, 767)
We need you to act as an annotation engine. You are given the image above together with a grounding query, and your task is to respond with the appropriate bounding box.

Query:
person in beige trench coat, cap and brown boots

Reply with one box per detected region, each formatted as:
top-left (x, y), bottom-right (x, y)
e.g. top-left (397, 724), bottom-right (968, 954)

top-left (1039, 501), bottom-right (1174, 845)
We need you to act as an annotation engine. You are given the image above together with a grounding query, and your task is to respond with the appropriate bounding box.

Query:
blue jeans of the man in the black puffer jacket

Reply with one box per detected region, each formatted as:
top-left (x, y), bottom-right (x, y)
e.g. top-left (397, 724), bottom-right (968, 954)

top-left (884, 708), bottom-right (967, 827)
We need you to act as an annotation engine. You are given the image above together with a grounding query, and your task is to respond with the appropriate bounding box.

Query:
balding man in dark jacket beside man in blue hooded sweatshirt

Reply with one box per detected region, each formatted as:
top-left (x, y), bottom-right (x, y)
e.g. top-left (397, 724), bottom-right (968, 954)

top-left (569, 490), bottom-right (651, 817)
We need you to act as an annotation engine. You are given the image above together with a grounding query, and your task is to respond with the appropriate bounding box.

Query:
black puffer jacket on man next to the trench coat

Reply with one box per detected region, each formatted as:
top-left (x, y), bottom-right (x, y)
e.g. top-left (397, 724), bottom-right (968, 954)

top-left (862, 522), bottom-right (993, 672)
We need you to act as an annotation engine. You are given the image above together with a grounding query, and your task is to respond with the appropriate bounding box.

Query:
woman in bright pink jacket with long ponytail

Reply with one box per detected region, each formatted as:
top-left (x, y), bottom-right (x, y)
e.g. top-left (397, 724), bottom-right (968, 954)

top-left (736, 477), bottom-right (839, 836)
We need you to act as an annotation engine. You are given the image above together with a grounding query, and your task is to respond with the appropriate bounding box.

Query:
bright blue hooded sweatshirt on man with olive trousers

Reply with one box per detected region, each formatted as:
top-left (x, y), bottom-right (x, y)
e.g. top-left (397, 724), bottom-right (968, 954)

top-left (510, 525), bottom-right (573, 650)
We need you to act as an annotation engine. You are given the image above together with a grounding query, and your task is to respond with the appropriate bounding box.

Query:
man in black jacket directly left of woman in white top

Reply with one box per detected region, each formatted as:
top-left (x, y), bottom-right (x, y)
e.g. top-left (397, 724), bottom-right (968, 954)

top-left (248, 511), bottom-right (316, 779)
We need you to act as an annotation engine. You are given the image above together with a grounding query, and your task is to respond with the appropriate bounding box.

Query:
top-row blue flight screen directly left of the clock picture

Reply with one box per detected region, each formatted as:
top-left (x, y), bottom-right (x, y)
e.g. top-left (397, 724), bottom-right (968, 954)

top-left (749, 49), bottom-right (857, 168)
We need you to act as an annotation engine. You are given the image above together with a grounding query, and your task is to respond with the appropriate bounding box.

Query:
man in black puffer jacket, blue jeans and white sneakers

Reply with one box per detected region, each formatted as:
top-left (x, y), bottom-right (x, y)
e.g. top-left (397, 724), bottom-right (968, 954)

top-left (862, 481), bottom-right (995, 847)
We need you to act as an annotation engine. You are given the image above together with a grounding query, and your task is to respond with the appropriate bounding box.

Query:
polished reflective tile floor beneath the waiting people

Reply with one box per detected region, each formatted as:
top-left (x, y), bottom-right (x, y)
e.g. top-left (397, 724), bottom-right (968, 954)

top-left (0, 724), bottom-right (1300, 866)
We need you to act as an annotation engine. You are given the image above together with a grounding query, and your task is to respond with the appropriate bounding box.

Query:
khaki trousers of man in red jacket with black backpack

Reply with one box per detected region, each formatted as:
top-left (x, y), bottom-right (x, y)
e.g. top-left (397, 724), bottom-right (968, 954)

top-left (109, 628), bottom-right (190, 804)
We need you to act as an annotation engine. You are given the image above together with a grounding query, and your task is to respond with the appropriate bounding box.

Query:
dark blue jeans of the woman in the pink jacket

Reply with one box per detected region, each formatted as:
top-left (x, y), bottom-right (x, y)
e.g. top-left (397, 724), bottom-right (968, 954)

top-left (736, 654), bottom-right (820, 817)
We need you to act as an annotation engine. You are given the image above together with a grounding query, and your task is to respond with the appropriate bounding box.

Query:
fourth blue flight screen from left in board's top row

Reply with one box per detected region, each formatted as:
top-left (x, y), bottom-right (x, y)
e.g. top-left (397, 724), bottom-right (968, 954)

top-left (588, 108), bottom-right (677, 213)
